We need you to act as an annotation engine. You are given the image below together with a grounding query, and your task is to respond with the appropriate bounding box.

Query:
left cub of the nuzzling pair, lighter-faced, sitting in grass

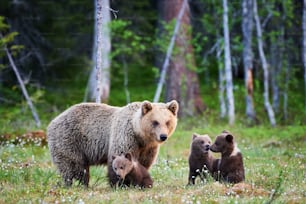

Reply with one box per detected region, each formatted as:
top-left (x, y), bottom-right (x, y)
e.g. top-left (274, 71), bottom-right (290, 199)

top-left (188, 133), bottom-right (217, 185)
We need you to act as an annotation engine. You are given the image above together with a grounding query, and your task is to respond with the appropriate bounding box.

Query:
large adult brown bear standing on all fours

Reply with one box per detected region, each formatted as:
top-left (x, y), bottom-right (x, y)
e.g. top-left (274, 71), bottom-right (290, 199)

top-left (47, 101), bottom-right (178, 186)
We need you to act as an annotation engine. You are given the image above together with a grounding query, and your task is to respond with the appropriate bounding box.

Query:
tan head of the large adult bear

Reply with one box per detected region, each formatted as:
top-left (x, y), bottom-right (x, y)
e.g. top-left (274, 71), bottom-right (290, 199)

top-left (140, 101), bottom-right (178, 143)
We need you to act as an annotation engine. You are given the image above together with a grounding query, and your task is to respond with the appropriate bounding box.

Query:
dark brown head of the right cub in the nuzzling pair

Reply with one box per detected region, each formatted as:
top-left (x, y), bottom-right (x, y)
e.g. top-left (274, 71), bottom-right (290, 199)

top-left (210, 131), bottom-right (234, 153)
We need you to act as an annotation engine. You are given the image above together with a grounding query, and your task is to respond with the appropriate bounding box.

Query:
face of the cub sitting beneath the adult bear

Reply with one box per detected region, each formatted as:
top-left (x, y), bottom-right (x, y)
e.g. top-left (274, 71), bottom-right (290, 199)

top-left (112, 153), bottom-right (133, 179)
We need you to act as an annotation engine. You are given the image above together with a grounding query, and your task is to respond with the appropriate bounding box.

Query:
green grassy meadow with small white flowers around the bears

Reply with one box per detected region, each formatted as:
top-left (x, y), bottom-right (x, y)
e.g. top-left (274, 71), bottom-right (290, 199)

top-left (0, 118), bottom-right (306, 203)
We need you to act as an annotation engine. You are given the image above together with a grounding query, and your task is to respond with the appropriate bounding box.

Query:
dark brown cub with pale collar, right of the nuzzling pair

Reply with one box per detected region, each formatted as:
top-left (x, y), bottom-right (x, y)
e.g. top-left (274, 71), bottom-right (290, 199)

top-left (210, 130), bottom-right (245, 183)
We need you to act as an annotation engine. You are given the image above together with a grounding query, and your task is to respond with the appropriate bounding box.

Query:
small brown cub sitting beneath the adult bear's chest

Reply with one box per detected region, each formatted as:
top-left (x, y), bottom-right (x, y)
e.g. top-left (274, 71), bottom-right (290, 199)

top-left (112, 153), bottom-right (153, 188)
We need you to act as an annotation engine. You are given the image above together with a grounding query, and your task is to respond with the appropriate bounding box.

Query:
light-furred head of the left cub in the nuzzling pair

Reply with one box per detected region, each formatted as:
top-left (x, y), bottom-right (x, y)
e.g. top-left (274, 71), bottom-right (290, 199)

top-left (191, 133), bottom-right (211, 154)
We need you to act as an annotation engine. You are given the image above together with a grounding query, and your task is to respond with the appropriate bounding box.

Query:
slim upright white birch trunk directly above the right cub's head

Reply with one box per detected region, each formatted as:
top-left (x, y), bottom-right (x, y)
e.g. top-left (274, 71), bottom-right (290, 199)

top-left (223, 0), bottom-right (235, 125)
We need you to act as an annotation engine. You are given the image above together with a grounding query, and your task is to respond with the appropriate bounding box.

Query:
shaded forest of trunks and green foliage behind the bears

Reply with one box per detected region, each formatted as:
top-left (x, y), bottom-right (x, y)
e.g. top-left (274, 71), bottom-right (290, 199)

top-left (0, 0), bottom-right (306, 126)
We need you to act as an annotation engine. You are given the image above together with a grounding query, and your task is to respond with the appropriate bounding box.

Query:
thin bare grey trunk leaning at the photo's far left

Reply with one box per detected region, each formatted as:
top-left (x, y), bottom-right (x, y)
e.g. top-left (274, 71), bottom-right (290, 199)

top-left (4, 46), bottom-right (41, 127)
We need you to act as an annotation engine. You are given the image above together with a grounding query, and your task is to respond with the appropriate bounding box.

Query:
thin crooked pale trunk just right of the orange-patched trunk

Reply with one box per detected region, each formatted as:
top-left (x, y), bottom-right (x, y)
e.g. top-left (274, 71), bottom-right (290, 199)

top-left (254, 0), bottom-right (276, 126)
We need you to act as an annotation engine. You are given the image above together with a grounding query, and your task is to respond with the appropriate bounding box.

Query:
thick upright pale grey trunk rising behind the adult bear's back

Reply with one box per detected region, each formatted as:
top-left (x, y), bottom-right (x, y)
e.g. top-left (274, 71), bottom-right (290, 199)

top-left (84, 0), bottom-right (111, 103)
